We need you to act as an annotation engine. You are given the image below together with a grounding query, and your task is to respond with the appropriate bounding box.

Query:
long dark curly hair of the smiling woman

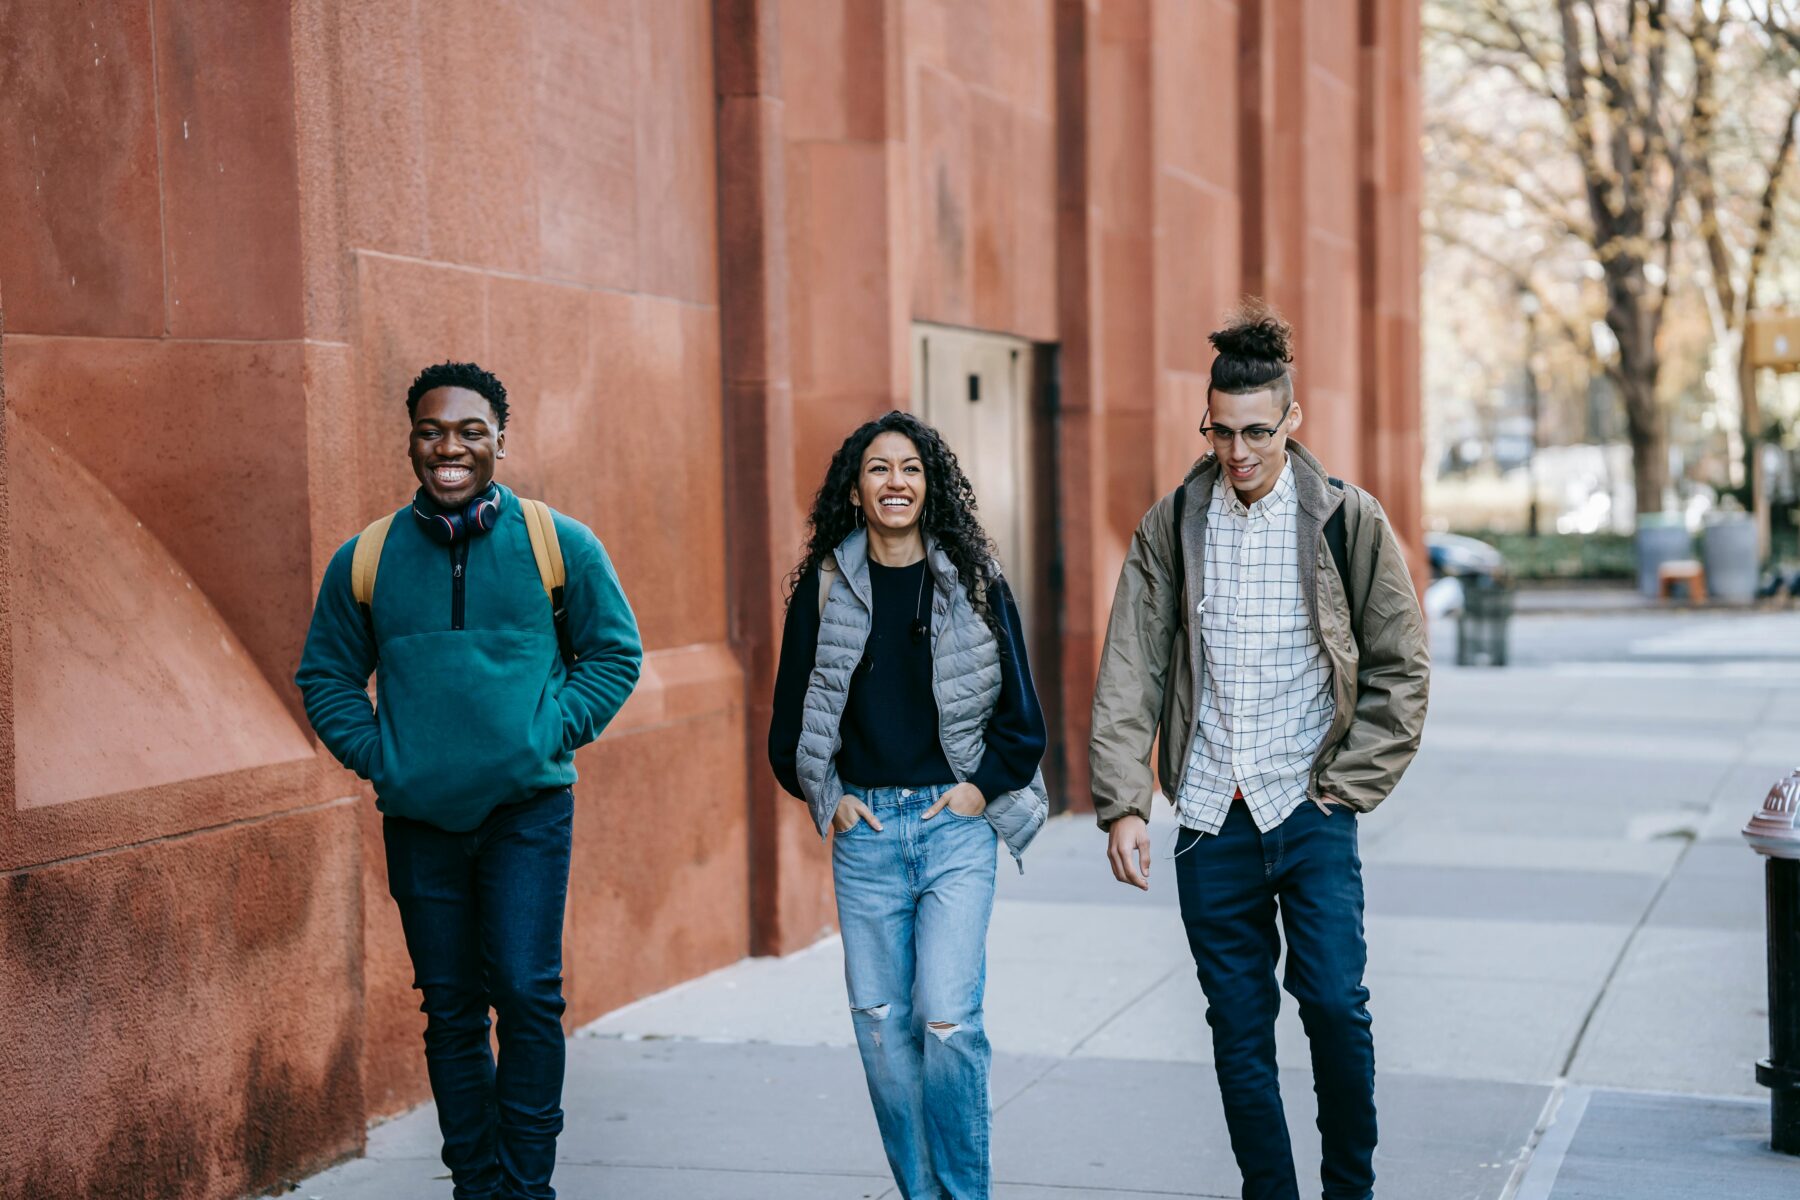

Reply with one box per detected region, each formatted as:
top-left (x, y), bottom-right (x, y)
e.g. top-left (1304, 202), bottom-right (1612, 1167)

top-left (788, 410), bottom-right (1004, 642)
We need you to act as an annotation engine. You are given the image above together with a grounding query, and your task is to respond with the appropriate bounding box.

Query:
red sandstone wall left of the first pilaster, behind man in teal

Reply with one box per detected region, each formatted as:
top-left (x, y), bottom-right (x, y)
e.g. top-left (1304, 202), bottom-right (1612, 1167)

top-left (0, 0), bottom-right (749, 1198)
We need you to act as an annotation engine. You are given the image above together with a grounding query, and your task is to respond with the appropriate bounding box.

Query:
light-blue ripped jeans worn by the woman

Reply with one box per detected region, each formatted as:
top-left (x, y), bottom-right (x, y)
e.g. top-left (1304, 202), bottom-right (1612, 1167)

top-left (832, 786), bottom-right (995, 1200)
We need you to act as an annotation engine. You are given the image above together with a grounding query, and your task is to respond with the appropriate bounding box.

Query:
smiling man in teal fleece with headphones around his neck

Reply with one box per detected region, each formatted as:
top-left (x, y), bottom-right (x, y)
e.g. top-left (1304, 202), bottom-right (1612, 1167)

top-left (295, 363), bottom-right (643, 1200)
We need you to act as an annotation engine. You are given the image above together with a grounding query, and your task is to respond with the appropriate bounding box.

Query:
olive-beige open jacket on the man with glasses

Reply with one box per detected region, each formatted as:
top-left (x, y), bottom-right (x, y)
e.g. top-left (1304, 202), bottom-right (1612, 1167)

top-left (1089, 441), bottom-right (1431, 828)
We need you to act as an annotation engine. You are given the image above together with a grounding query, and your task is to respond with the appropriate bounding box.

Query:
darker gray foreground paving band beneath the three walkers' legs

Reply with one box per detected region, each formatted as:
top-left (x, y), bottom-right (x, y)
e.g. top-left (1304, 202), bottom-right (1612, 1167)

top-left (302, 1038), bottom-right (1544, 1200)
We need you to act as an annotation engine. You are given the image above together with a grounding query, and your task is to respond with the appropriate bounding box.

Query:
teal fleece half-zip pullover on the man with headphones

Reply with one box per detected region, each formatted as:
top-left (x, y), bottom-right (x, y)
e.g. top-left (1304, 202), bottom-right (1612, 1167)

top-left (293, 486), bottom-right (643, 833)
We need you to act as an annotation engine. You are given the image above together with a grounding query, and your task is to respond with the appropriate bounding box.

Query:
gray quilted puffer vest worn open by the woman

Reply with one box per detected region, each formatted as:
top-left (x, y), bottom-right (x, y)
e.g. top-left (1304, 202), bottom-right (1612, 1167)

top-left (796, 529), bottom-right (1049, 871)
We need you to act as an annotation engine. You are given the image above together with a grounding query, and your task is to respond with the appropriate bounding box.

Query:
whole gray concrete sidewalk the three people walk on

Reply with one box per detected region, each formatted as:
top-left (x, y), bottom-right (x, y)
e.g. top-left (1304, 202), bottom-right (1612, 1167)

top-left (299, 613), bottom-right (1800, 1200)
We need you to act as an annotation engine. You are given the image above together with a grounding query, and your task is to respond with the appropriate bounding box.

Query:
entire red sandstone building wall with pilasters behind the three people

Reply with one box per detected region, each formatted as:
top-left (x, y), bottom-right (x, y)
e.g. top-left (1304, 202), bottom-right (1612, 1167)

top-left (0, 0), bottom-right (1418, 1196)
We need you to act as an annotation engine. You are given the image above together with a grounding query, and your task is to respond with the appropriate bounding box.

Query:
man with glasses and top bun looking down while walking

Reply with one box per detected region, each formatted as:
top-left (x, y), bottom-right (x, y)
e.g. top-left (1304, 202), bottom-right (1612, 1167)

top-left (1089, 302), bottom-right (1429, 1200)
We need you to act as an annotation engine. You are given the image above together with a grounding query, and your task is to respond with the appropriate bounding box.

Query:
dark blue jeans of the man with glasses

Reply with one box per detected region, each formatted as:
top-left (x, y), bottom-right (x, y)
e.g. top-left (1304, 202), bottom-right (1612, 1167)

top-left (1175, 801), bottom-right (1375, 1200)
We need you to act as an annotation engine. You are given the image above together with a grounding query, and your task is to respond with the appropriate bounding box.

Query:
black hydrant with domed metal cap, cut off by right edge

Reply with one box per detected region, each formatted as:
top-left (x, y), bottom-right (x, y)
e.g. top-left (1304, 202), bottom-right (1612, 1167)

top-left (1744, 770), bottom-right (1800, 1155)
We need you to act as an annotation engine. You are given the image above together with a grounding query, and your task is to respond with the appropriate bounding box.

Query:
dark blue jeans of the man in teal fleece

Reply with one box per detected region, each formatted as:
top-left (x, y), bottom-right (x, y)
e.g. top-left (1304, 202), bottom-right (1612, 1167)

top-left (382, 788), bottom-right (574, 1200)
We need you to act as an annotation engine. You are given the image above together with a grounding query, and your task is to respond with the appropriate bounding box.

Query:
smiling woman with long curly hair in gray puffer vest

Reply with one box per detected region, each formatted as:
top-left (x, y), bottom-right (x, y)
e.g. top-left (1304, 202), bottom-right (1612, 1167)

top-left (769, 412), bottom-right (1049, 1196)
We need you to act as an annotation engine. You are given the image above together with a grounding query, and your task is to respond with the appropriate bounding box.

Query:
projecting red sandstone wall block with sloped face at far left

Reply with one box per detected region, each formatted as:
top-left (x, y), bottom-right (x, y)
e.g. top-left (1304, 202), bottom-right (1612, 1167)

top-left (0, 0), bottom-right (364, 1198)
